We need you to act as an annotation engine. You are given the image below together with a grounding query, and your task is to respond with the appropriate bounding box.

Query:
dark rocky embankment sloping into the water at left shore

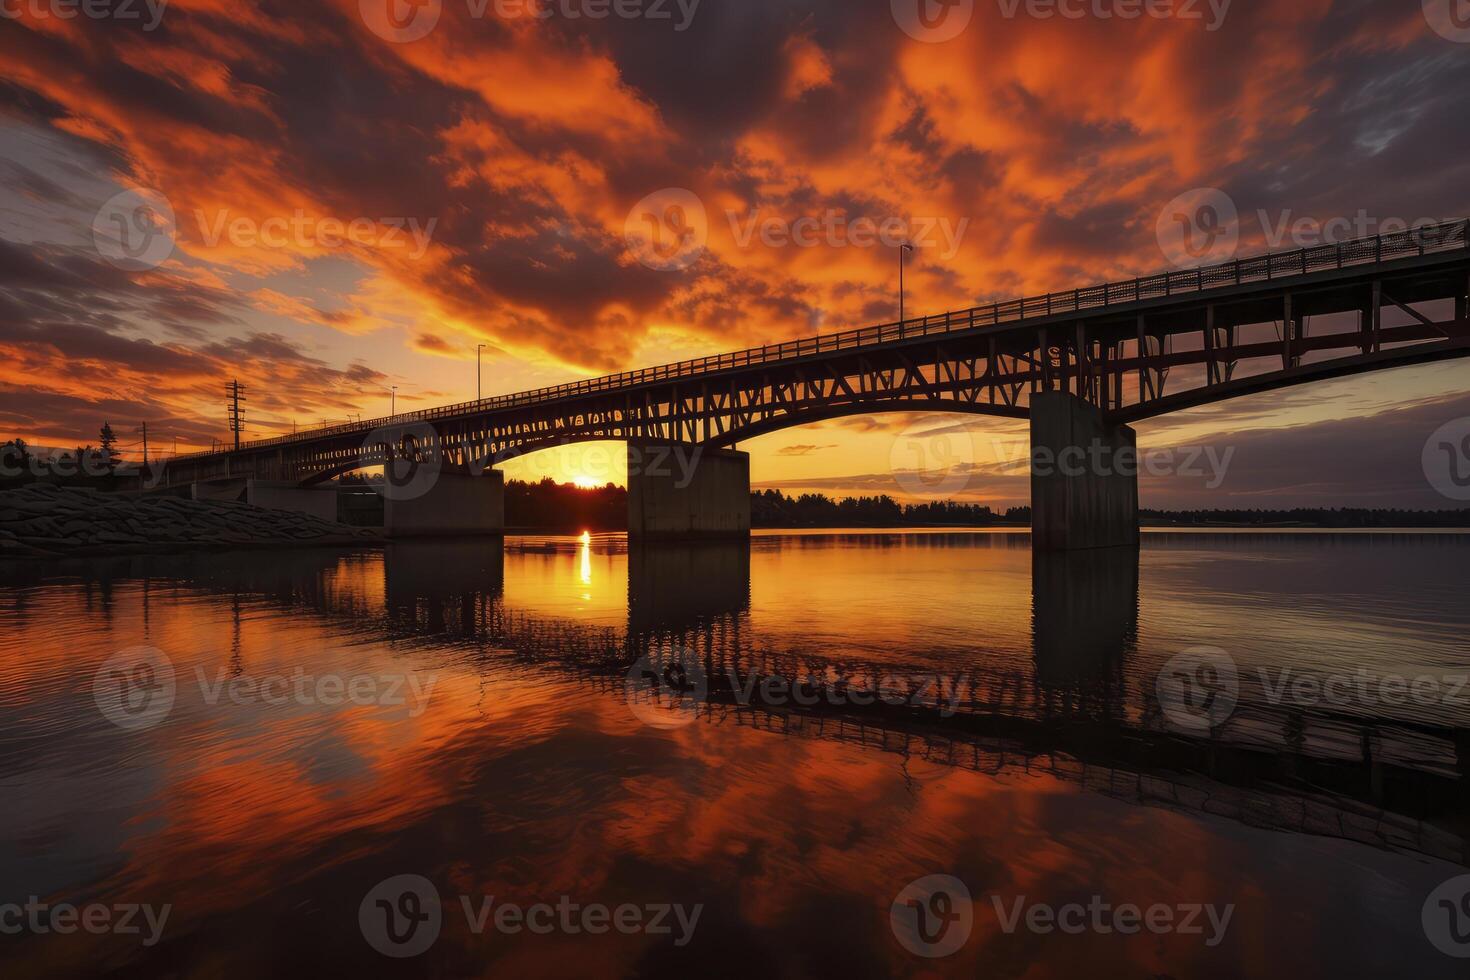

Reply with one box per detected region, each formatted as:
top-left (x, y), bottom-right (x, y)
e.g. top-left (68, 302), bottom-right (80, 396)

top-left (0, 483), bottom-right (378, 558)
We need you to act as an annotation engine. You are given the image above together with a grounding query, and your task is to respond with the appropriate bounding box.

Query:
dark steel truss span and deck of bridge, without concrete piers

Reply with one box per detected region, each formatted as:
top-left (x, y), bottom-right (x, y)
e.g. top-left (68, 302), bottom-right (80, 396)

top-left (162, 219), bottom-right (1470, 485)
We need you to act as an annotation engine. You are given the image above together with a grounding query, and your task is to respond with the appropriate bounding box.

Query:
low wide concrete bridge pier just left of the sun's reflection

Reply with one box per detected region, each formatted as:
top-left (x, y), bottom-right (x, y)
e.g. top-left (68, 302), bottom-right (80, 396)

top-left (382, 470), bottom-right (506, 538)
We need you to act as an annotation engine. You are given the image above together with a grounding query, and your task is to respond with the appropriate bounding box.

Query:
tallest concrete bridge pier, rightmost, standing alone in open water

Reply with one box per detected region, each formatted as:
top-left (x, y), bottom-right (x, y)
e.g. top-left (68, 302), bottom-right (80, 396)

top-left (1030, 391), bottom-right (1138, 551)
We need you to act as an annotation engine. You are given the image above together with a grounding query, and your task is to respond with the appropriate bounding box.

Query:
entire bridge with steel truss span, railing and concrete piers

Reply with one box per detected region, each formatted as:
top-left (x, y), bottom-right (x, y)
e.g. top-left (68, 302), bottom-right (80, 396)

top-left (159, 219), bottom-right (1470, 550)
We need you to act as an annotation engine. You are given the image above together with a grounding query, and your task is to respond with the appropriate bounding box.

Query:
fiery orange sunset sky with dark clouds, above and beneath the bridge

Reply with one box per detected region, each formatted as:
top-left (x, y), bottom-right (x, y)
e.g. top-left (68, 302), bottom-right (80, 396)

top-left (0, 0), bottom-right (1470, 507)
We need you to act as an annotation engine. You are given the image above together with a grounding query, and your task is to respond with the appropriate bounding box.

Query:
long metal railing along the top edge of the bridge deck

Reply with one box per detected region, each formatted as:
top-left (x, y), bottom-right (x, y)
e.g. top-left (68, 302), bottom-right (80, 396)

top-left (173, 219), bottom-right (1470, 461)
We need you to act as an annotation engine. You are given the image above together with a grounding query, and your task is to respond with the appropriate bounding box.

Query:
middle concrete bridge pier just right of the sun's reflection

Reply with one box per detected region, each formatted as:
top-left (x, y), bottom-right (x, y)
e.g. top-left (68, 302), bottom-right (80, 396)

top-left (628, 442), bottom-right (750, 539)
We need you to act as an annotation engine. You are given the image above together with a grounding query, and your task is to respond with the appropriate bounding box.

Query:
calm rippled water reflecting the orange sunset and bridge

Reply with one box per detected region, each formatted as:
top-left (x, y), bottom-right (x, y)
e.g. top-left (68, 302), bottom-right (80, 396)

top-left (0, 532), bottom-right (1470, 977)
